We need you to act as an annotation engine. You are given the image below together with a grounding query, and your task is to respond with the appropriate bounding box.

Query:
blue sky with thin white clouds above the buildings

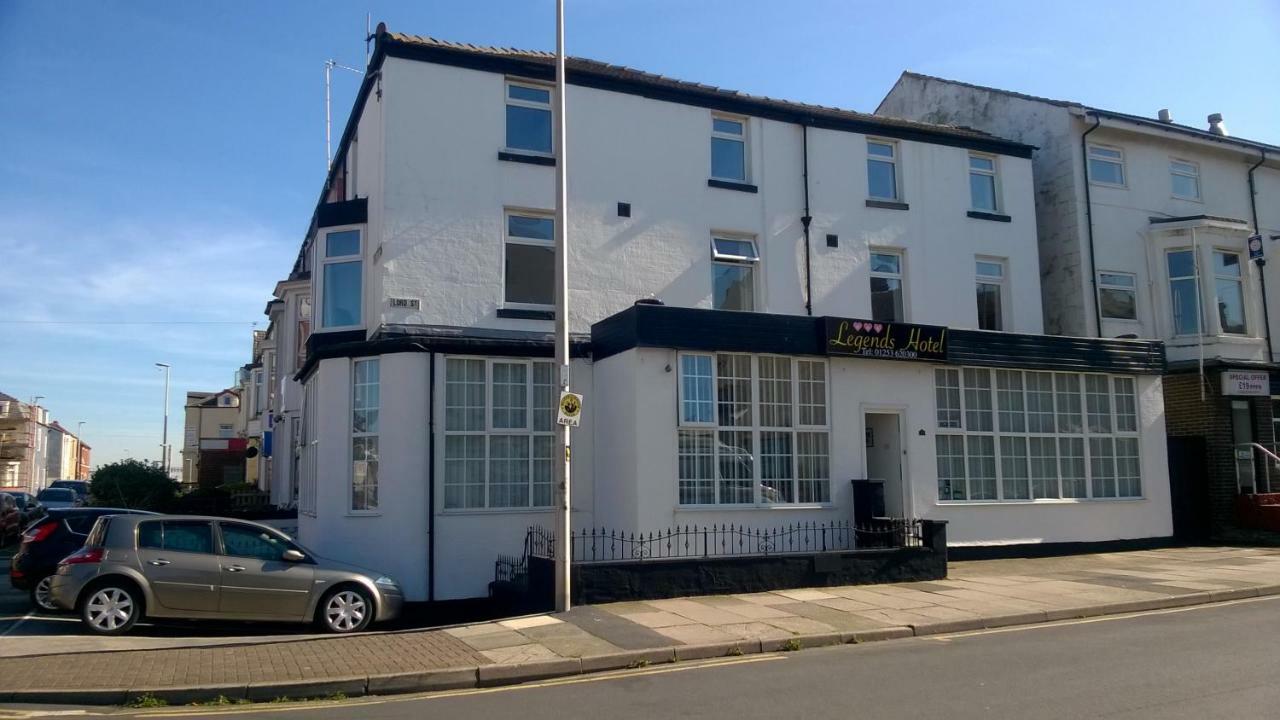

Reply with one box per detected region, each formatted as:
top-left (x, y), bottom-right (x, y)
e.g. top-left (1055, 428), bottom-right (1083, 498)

top-left (0, 0), bottom-right (1280, 464)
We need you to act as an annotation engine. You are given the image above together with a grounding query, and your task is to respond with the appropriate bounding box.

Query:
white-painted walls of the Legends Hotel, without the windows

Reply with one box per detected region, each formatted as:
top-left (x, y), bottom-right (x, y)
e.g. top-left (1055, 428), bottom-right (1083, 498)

top-left (290, 31), bottom-right (1169, 601)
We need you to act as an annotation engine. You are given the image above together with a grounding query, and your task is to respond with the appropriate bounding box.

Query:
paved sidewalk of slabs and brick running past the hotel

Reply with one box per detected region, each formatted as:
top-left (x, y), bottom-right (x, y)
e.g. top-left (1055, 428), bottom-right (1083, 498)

top-left (0, 547), bottom-right (1280, 703)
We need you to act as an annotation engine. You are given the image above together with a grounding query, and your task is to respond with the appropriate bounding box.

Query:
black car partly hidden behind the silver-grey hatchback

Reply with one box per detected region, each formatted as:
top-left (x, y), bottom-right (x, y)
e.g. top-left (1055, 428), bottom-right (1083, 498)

top-left (9, 507), bottom-right (155, 611)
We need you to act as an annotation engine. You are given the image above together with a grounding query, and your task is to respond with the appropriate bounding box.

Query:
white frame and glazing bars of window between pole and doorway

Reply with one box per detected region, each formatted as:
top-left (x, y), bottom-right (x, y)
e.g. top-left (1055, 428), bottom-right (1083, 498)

top-left (672, 352), bottom-right (835, 510)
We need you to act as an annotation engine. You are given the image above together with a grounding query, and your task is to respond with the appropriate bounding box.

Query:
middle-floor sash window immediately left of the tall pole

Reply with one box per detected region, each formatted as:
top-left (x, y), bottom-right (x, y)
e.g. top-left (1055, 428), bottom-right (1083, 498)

top-left (503, 213), bottom-right (556, 307)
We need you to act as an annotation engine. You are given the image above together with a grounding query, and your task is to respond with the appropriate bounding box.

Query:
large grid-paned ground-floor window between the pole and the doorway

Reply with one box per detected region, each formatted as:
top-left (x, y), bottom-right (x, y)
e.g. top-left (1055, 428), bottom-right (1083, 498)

top-left (676, 354), bottom-right (831, 506)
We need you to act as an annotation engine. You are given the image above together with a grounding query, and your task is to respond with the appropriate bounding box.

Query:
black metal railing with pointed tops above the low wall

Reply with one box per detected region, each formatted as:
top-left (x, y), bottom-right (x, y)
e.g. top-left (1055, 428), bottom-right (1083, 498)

top-left (525, 518), bottom-right (923, 562)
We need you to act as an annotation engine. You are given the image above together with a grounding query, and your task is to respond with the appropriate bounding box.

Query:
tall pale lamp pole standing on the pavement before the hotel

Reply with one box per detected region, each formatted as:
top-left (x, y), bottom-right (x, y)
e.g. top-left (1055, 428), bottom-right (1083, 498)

top-left (554, 0), bottom-right (572, 612)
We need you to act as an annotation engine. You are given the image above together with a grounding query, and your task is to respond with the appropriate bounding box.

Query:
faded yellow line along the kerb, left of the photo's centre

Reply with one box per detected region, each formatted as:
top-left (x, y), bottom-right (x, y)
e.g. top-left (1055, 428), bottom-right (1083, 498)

top-left (128, 653), bottom-right (786, 717)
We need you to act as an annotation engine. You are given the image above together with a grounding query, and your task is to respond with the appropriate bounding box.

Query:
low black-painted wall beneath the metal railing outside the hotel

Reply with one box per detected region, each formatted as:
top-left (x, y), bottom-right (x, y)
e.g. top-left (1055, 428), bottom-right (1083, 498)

top-left (529, 520), bottom-right (947, 605)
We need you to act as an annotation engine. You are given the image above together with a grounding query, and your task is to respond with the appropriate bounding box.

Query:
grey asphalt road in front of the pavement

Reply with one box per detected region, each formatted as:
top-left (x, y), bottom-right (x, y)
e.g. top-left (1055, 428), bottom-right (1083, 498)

top-left (102, 598), bottom-right (1280, 720)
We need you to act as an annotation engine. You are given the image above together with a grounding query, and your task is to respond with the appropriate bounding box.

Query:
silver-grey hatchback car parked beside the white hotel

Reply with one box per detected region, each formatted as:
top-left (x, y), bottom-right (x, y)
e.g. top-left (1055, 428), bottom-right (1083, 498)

top-left (50, 515), bottom-right (404, 635)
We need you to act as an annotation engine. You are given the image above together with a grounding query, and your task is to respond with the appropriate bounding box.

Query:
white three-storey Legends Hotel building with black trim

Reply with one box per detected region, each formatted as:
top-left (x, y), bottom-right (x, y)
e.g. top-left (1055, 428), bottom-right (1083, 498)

top-left (275, 27), bottom-right (1170, 601)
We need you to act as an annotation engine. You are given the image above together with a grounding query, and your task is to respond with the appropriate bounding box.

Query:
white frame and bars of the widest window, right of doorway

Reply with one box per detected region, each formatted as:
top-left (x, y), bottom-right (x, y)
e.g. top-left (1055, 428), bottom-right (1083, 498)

top-left (933, 365), bottom-right (1149, 505)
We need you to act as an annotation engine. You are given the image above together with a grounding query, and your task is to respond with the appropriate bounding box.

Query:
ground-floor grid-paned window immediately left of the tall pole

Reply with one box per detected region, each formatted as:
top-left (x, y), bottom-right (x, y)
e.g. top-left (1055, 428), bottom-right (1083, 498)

top-left (444, 357), bottom-right (557, 510)
